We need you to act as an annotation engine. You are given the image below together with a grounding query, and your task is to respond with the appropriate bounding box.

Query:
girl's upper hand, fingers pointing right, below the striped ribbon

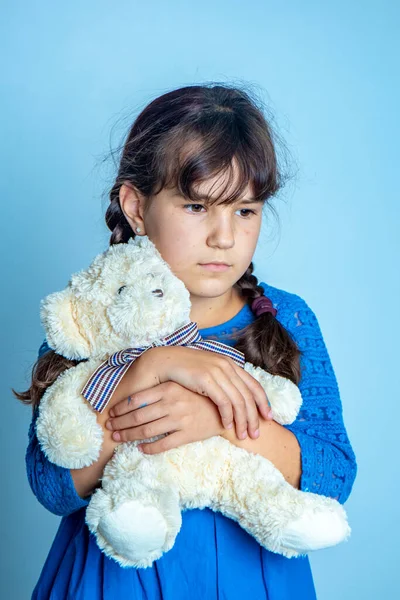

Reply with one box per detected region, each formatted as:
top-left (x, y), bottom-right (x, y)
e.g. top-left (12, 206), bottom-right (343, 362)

top-left (141, 346), bottom-right (272, 439)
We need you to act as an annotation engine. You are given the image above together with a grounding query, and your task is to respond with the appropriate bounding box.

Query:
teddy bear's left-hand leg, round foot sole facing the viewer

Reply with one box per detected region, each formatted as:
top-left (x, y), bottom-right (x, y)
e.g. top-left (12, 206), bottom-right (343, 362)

top-left (86, 438), bottom-right (182, 568)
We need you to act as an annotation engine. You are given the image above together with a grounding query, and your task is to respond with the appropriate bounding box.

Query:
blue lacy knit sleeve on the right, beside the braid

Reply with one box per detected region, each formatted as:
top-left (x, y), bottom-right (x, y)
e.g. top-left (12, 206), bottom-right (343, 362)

top-left (278, 295), bottom-right (357, 504)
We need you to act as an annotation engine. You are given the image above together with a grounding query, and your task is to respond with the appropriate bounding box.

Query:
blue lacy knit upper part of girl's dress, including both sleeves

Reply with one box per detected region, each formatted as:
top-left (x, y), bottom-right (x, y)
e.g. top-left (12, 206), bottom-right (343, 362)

top-left (26, 282), bottom-right (357, 516)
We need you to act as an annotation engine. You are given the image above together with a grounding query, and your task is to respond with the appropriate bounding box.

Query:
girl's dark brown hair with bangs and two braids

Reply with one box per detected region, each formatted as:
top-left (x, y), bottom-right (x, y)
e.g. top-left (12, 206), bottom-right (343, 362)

top-left (13, 84), bottom-right (300, 407)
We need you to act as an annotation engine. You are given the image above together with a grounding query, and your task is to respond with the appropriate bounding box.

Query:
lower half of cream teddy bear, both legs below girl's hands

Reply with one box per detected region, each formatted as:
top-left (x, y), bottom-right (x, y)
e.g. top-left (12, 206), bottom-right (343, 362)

top-left (86, 436), bottom-right (350, 567)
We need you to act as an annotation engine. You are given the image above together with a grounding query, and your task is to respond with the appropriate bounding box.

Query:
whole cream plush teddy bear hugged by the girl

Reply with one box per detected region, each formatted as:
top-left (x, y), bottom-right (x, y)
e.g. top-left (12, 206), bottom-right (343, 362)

top-left (36, 236), bottom-right (350, 567)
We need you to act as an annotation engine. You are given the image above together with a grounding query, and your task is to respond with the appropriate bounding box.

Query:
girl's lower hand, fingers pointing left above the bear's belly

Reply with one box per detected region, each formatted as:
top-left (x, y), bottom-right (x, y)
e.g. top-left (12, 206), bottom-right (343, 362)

top-left (106, 381), bottom-right (224, 454)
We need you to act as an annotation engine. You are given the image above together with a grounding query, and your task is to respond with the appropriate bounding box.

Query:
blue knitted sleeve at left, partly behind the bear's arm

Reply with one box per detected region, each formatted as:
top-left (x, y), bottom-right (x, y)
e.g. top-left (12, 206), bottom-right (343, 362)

top-left (25, 343), bottom-right (90, 516)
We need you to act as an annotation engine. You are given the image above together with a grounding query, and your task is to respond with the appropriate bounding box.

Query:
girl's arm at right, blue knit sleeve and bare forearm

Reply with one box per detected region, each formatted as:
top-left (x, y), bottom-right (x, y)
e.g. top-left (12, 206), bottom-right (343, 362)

top-left (223, 295), bottom-right (357, 503)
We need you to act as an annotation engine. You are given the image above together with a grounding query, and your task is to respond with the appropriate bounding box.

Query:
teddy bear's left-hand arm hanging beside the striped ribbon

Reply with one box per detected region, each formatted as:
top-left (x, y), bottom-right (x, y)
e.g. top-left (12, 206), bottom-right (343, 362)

top-left (36, 360), bottom-right (103, 469)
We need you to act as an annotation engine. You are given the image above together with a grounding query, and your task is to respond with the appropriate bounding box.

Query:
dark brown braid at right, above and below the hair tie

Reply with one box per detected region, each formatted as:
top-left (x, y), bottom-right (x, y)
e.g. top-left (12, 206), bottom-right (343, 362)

top-left (235, 262), bottom-right (301, 385)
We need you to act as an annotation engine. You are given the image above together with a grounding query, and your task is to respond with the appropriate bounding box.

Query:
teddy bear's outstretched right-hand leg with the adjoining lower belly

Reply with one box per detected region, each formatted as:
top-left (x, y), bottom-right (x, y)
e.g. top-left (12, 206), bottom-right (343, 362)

top-left (173, 436), bottom-right (350, 557)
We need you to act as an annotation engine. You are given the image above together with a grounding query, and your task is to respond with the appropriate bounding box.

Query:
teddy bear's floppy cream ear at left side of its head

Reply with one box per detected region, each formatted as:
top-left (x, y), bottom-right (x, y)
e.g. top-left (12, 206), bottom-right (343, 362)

top-left (40, 288), bottom-right (90, 360)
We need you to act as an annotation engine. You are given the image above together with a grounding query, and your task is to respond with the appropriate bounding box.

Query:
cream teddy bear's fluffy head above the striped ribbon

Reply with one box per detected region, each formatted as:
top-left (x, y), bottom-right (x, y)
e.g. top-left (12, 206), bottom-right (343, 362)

top-left (40, 236), bottom-right (191, 360)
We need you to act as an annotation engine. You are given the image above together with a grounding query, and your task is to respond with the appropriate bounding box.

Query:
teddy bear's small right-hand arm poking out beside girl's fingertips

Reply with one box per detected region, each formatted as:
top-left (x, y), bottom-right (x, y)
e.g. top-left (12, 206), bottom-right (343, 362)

top-left (244, 362), bottom-right (302, 425)
